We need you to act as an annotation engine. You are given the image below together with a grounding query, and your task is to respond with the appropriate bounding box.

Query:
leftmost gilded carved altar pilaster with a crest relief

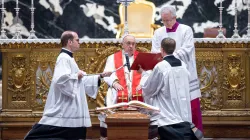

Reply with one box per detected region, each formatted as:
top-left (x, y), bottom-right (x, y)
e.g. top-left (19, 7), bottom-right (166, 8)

top-left (7, 54), bottom-right (31, 108)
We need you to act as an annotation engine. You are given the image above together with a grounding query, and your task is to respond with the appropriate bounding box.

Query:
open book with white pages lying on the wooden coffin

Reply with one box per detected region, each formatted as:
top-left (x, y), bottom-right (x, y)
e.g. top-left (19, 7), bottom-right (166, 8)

top-left (96, 100), bottom-right (160, 112)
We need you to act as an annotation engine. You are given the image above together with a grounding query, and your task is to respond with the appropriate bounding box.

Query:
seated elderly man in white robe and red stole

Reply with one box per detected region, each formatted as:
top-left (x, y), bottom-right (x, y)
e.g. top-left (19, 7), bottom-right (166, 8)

top-left (99, 34), bottom-right (157, 139)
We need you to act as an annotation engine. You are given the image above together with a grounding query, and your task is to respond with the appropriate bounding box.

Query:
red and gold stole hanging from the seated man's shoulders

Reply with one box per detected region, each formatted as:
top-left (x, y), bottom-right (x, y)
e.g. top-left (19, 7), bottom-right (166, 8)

top-left (114, 51), bottom-right (143, 103)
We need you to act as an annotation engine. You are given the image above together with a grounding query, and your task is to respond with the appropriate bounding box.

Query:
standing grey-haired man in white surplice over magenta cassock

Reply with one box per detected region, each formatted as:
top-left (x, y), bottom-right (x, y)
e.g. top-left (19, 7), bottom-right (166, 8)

top-left (151, 6), bottom-right (203, 131)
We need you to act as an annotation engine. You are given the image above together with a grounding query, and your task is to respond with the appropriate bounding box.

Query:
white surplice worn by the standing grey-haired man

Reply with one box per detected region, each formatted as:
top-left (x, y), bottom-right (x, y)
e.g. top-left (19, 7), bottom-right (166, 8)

top-left (151, 24), bottom-right (201, 100)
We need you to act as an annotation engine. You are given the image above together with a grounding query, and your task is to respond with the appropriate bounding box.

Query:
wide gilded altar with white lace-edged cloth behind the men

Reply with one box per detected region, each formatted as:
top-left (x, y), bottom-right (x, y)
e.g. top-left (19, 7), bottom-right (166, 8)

top-left (0, 38), bottom-right (250, 139)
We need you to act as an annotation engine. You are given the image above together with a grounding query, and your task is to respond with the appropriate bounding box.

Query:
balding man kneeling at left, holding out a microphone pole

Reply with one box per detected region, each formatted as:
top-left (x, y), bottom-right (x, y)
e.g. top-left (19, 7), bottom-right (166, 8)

top-left (24, 31), bottom-right (111, 140)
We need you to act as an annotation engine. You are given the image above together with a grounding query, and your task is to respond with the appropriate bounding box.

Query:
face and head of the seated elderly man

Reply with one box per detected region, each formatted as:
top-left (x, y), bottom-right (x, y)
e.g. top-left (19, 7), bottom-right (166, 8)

top-left (122, 35), bottom-right (136, 56)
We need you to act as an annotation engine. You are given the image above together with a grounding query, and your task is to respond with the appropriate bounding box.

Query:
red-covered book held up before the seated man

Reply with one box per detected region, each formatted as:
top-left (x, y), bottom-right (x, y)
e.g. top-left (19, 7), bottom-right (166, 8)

top-left (131, 53), bottom-right (162, 70)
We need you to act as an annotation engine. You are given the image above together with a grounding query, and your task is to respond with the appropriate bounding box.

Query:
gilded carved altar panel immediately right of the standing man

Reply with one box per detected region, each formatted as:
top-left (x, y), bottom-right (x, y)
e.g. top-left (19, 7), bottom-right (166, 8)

top-left (196, 51), bottom-right (223, 110)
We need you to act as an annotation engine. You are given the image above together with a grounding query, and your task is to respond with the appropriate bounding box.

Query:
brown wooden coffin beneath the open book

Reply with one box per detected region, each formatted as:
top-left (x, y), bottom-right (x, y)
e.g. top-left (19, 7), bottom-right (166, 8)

top-left (106, 109), bottom-right (150, 140)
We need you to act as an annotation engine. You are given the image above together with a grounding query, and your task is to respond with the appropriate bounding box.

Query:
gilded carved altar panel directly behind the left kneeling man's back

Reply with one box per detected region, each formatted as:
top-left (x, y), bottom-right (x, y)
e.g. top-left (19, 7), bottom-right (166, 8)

top-left (30, 50), bottom-right (59, 110)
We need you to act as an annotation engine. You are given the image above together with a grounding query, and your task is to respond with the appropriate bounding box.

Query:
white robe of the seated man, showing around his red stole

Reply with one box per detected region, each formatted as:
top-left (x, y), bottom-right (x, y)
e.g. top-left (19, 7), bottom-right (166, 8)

top-left (103, 51), bottom-right (134, 106)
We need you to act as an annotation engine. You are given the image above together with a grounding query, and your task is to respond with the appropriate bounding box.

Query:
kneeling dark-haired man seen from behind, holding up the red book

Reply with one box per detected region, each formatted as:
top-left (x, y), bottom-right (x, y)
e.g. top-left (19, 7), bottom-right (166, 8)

top-left (139, 38), bottom-right (196, 140)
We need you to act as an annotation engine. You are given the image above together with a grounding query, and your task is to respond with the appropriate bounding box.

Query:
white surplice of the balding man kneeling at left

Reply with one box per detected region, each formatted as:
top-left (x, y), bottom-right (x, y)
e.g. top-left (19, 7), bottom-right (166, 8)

top-left (39, 49), bottom-right (98, 127)
